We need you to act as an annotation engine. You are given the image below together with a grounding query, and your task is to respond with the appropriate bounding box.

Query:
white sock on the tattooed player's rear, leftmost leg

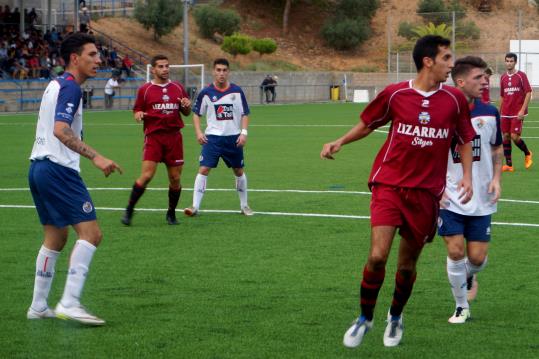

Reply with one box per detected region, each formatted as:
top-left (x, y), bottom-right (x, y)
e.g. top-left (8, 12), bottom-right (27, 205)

top-left (30, 246), bottom-right (60, 312)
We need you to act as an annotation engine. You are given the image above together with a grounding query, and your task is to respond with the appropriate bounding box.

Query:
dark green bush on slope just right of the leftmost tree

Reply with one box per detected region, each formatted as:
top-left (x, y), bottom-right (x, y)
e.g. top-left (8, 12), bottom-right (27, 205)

top-left (193, 5), bottom-right (240, 39)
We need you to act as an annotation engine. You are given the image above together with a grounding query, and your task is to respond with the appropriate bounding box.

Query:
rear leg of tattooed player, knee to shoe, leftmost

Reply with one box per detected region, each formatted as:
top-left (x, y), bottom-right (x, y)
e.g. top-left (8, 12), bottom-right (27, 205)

top-left (27, 225), bottom-right (68, 319)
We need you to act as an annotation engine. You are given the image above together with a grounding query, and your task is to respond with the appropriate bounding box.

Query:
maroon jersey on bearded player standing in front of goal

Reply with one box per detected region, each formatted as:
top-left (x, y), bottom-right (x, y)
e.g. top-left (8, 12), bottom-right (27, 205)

top-left (133, 81), bottom-right (189, 135)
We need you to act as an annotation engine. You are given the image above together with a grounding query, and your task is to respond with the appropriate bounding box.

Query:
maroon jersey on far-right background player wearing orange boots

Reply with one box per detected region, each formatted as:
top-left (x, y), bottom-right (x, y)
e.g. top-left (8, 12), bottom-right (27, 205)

top-left (500, 71), bottom-right (532, 117)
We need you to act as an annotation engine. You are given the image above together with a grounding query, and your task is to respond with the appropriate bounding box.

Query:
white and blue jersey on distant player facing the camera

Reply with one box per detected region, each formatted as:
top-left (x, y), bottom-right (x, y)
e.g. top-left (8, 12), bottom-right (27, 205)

top-left (193, 84), bottom-right (249, 136)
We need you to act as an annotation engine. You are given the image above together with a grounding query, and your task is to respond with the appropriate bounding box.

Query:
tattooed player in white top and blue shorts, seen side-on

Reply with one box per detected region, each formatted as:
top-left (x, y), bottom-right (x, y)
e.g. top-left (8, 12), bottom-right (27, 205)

top-left (27, 32), bottom-right (122, 325)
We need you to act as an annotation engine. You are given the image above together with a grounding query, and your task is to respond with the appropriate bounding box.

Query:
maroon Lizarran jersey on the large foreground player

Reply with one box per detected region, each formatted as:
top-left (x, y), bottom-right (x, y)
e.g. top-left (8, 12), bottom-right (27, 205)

top-left (361, 81), bottom-right (475, 196)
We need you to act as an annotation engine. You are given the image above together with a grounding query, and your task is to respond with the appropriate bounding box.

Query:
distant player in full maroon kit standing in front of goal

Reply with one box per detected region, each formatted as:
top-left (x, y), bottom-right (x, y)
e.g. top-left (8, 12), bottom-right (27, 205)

top-left (122, 55), bottom-right (191, 226)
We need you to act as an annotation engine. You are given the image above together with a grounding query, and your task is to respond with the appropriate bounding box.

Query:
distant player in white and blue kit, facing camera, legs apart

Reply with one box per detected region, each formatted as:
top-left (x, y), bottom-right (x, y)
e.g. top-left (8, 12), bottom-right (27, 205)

top-left (184, 58), bottom-right (254, 217)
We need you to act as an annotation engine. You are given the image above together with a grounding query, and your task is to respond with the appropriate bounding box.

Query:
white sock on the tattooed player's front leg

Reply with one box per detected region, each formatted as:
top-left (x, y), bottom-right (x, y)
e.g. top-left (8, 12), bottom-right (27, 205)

top-left (61, 239), bottom-right (96, 307)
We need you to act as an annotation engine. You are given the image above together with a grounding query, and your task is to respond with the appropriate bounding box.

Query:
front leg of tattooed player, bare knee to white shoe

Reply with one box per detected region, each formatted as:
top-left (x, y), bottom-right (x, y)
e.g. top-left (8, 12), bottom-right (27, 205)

top-left (56, 220), bottom-right (105, 325)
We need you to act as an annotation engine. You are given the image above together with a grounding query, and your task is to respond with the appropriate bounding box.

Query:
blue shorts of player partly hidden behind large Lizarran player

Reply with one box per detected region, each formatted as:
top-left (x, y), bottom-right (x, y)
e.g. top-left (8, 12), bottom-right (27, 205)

top-left (438, 209), bottom-right (492, 242)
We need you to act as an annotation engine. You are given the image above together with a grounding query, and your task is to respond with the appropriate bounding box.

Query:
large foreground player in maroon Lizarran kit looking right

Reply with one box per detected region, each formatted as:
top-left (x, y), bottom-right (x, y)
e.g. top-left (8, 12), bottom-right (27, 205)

top-left (320, 35), bottom-right (475, 348)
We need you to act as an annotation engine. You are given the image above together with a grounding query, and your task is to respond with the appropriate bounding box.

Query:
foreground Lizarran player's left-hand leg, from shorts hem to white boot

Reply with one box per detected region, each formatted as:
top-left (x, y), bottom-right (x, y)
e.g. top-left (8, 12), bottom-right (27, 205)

top-left (343, 226), bottom-right (396, 348)
